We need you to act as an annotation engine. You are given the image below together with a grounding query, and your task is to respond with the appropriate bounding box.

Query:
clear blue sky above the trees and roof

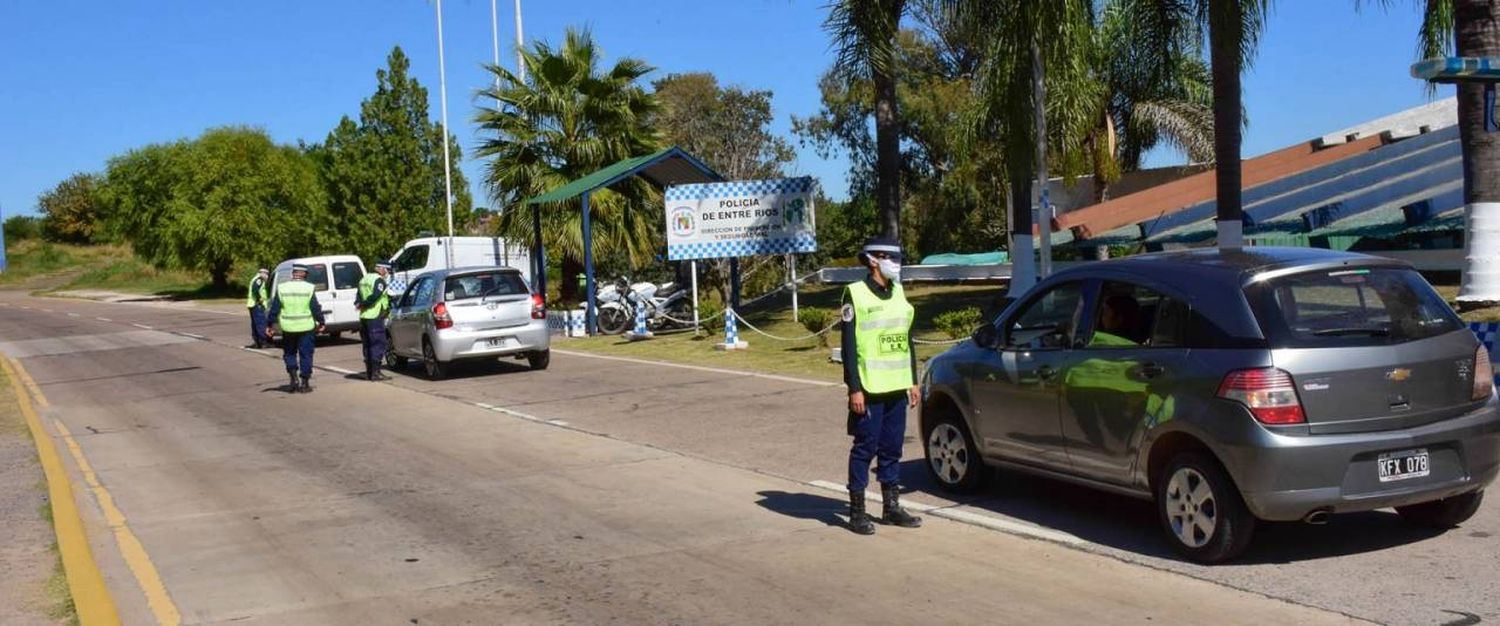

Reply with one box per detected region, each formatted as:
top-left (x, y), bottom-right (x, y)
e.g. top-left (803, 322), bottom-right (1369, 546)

top-left (0, 0), bottom-right (1452, 216)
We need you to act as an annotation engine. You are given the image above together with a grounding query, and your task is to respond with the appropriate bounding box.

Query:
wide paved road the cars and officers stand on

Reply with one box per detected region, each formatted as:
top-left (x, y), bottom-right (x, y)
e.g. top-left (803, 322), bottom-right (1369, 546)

top-left (0, 289), bottom-right (1500, 623)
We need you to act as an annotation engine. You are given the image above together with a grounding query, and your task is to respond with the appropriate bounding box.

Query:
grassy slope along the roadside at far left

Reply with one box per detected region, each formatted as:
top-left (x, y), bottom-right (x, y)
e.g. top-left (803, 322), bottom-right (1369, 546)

top-left (0, 240), bottom-right (245, 300)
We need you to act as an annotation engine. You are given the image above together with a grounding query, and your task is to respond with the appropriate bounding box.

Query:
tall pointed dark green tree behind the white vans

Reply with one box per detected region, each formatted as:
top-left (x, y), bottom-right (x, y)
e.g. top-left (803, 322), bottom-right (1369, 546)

top-left (309, 47), bottom-right (473, 258)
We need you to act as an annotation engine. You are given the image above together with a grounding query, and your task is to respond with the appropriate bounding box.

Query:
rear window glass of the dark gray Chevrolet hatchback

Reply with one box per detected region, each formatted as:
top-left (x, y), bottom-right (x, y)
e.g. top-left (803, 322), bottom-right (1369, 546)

top-left (1248, 267), bottom-right (1463, 347)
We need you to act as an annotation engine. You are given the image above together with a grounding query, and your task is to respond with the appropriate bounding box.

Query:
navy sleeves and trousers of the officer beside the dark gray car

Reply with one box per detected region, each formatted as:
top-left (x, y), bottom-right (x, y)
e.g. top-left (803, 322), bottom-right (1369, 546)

top-left (840, 276), bottom-right (918, 492)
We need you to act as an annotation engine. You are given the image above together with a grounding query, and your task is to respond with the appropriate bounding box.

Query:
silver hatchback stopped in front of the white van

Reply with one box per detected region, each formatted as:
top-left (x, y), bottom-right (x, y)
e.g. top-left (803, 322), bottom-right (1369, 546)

top-left (386, 267), bottom-right (552, 378)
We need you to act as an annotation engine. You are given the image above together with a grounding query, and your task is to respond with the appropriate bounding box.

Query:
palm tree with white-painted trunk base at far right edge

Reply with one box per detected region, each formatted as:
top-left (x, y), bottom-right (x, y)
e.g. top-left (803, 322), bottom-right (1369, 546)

top-left (1374, 0), bottom-right (1500, 308)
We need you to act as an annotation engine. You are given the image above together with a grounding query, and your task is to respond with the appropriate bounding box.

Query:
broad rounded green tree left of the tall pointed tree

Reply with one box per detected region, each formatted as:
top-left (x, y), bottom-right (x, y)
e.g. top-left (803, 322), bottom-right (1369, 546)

top-left (101, 128), bottom-right (329, 290)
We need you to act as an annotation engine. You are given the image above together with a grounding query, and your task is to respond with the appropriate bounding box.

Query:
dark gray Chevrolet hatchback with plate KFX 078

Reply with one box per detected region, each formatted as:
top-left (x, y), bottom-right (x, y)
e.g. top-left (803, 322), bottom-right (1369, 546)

top-left (921, 248), bottom-right (1500, 563)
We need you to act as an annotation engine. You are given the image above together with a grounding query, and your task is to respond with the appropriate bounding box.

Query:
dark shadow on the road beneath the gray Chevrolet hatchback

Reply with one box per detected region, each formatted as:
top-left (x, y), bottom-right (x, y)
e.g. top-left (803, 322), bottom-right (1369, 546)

top-left (902, 459), bottom-right (1442, 564)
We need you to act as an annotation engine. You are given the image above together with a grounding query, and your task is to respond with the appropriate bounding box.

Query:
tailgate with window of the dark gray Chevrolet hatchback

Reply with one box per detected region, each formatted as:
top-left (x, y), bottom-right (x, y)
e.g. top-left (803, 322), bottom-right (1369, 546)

top-left (1247, 266), bottom-right (1482, 434)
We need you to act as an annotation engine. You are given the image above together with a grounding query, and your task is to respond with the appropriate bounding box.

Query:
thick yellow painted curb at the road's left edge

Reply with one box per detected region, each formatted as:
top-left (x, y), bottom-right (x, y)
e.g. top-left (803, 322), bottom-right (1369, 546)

top-left (0, 359), bottom-right (120, 626)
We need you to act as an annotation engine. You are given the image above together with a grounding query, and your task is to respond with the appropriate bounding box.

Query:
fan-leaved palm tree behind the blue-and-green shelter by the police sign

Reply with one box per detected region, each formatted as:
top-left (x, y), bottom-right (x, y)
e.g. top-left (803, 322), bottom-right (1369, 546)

top-left (474, 29), bottom-right (662, 302)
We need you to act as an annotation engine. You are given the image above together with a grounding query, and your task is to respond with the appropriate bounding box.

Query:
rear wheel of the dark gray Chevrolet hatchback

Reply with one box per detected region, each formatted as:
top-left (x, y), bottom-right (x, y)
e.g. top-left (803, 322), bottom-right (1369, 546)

top-left (1157, 452), bottom-right (1256, 563)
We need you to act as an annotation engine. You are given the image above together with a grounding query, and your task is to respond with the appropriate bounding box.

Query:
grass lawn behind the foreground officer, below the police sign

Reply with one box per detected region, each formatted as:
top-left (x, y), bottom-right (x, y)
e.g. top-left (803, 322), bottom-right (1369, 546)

top-left (552, 284), bottom-right (1004, 381)
